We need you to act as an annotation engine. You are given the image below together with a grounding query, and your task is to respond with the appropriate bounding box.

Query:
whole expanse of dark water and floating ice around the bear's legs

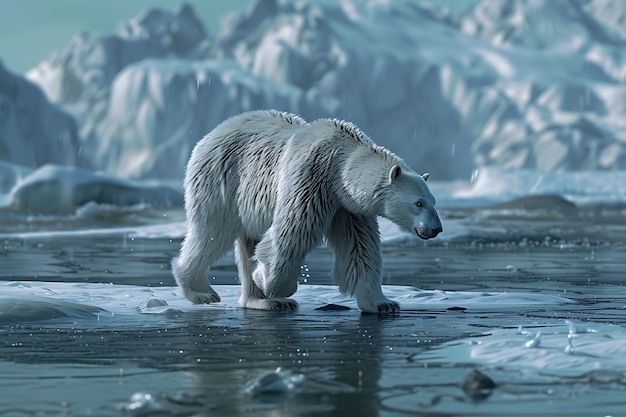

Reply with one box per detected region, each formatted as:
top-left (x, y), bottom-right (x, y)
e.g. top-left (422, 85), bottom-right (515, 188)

top-left (0, 206), bottom-right (626, 416)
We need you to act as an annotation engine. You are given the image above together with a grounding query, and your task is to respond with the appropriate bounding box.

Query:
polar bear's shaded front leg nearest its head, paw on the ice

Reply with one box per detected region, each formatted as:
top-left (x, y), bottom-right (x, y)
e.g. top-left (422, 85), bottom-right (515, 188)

top-left (327, 210), bottom-right (400, 313)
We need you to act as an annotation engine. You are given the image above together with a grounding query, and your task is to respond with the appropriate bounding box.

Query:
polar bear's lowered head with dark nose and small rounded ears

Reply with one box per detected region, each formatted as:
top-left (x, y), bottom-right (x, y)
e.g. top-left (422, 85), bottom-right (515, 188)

top-left (383, 165), bottom-right (443, 239)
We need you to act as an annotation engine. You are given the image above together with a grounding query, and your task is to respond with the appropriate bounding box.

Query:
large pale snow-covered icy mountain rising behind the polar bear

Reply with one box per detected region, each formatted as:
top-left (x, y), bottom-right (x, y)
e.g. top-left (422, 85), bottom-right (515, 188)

top-left (17, 0), bottom-right (626, 179)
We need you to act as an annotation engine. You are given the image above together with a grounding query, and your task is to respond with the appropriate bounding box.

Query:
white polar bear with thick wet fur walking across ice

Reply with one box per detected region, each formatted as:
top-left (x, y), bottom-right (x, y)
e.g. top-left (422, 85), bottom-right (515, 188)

top-left (172, 110), bottom-right (443, 312)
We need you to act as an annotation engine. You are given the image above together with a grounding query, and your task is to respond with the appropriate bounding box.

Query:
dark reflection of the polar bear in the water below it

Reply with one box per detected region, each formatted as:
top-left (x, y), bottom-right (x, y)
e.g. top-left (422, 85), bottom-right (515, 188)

top-left (177, 310), bottom-right (393, 417)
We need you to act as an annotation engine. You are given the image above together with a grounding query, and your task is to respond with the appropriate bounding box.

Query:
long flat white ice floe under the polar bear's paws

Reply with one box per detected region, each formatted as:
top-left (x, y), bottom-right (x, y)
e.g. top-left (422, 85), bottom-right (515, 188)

top-left (0, 281), bottom-right (575, 324)
